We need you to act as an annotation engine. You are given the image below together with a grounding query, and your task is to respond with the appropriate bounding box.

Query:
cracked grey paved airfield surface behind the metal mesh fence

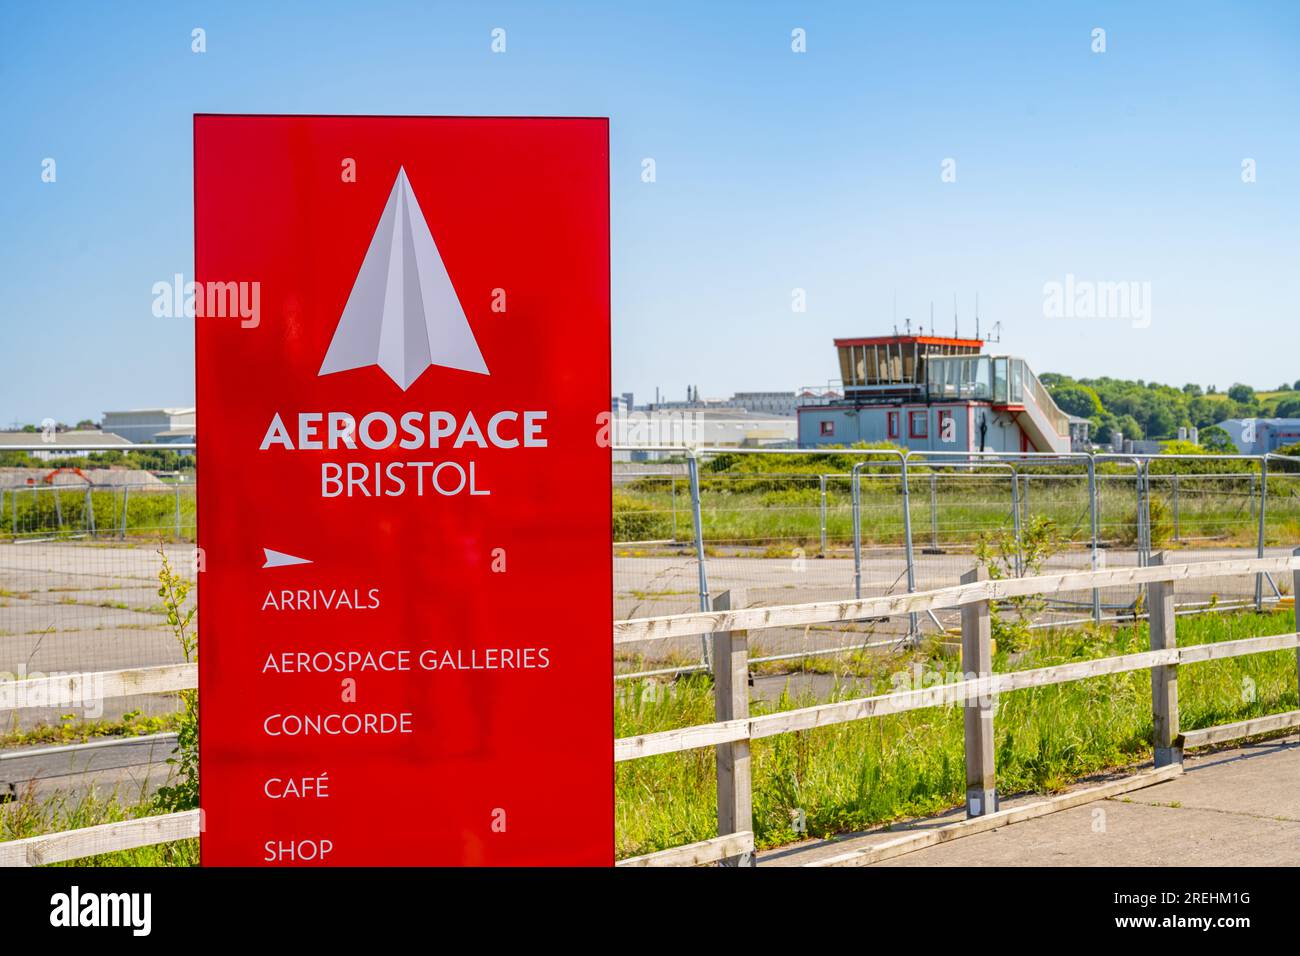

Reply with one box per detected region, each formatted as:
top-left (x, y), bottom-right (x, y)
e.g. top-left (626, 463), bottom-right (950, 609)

top-left (0, 542), bottom-right (1290, 697)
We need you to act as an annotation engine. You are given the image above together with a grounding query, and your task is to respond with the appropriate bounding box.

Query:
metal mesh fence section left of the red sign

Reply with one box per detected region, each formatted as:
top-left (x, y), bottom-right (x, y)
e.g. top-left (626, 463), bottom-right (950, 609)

top-left (0, 475), bottom-right (195, 732)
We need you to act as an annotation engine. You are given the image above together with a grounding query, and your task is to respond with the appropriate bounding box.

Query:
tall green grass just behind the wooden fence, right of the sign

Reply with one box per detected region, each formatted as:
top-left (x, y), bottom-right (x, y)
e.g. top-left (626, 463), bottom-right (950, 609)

top-left (615, 613), bottom-right (1297, 857)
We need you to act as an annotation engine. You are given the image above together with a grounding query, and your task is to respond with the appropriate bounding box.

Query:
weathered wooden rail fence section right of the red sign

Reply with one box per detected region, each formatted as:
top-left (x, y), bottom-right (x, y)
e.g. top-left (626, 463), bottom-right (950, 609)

top-left (614, 549), bottom-right (1300, 865)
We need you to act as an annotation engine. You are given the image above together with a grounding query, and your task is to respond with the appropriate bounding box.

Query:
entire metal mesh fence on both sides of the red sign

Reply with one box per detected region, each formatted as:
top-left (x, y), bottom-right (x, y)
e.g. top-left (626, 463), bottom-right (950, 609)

top-left (0, 450), bottom-right (1300, 702)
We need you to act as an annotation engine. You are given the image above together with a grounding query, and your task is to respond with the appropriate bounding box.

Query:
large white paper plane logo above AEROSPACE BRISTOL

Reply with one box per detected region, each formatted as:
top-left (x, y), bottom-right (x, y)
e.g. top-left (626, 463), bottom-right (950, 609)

top-left (320, 169), bottom-right (488, 392)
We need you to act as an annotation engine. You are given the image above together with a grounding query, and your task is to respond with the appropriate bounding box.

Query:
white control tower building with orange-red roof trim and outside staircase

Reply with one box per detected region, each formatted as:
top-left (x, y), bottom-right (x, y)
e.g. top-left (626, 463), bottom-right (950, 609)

top-left (798, 334), bottom-right (1071, 453)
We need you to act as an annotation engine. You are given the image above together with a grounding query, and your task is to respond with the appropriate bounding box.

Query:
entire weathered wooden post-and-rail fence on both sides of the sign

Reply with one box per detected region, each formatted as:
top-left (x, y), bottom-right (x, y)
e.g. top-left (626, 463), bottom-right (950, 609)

top-left (0, 549), bottom-right (1300, 866)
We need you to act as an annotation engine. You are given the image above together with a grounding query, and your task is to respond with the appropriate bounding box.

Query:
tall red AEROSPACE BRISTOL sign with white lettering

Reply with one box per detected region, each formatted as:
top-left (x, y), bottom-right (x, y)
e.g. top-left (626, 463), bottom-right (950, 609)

top-left (196, 116), bottom-right (614, 865)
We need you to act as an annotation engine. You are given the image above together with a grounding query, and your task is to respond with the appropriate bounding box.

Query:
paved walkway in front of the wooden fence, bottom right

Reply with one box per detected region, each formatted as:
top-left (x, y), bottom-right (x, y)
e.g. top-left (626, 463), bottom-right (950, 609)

top-left (759, 734), bottom-right (1300, 866)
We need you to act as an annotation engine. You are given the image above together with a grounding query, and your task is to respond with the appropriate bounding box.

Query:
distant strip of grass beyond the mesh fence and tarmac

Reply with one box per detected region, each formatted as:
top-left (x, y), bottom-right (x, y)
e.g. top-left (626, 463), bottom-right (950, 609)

top-left (0, 463), bottom-right (1300, 557)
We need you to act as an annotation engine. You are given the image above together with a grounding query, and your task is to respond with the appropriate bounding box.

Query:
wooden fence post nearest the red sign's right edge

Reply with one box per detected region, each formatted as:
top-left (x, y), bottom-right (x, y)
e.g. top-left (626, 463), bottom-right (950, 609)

top-left (712, 589), bottom-right (757, 866)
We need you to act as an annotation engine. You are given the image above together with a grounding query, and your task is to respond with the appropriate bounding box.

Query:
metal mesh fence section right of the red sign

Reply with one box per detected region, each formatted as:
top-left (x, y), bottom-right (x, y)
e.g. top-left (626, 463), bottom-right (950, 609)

top-left (615, 451), bottom-right (1300, 666)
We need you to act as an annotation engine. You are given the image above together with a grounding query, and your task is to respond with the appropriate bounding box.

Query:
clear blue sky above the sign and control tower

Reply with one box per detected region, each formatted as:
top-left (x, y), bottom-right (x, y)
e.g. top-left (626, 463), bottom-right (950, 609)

top-left (0, 0), bottom-right (1300, 424)
